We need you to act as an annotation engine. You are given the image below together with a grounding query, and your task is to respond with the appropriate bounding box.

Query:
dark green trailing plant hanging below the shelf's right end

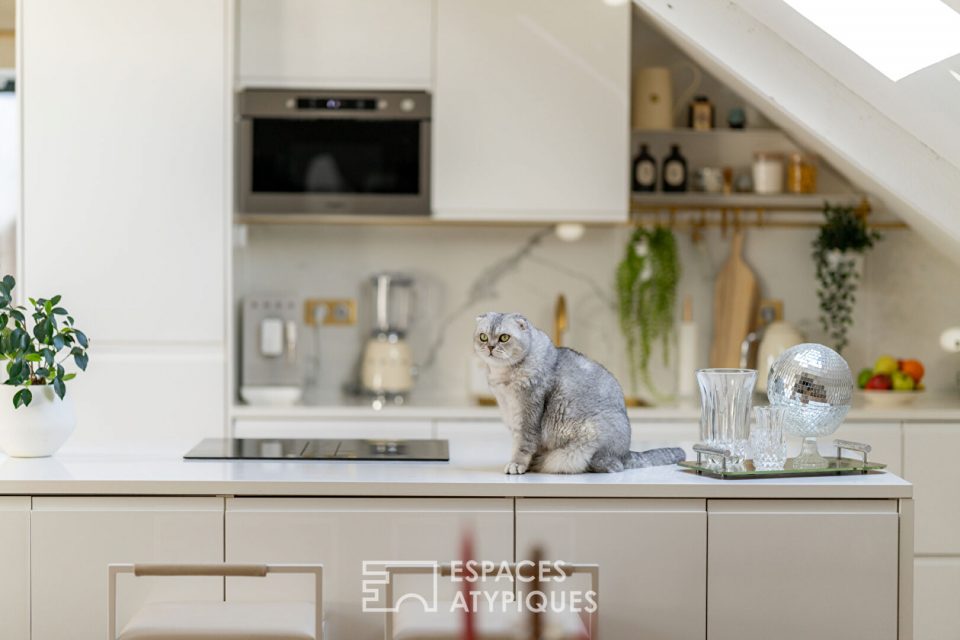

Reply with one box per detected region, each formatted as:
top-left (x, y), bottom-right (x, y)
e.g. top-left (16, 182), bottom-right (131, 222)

top-left (813, 203), bottom-right (881, 352)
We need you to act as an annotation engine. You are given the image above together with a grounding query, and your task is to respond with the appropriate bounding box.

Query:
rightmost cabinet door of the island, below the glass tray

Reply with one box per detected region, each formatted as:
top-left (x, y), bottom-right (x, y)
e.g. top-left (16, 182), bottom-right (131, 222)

top-left (707, 500), bottom-right (899, 640)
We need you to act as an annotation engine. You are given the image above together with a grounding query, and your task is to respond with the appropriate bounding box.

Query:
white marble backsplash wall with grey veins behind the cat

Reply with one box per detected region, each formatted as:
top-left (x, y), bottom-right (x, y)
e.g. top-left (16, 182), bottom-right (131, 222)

top-left (236, 226), bottom-right (960, 402)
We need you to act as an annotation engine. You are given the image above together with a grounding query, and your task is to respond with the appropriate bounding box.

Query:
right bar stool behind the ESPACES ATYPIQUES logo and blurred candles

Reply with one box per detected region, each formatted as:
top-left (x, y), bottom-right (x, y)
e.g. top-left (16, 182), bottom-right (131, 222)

top-left (384, 564), bottom-right (600, 640)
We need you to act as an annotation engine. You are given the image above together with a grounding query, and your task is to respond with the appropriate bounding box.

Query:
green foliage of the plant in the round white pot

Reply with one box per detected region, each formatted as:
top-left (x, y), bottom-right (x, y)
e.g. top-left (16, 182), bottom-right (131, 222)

top-left (0, 275), bottom-right (89, 409)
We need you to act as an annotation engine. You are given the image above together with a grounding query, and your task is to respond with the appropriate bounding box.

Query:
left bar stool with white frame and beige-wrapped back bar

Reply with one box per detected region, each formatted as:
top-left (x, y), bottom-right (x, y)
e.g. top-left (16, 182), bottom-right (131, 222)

top-left (109, 564), bottom-right (323, 640)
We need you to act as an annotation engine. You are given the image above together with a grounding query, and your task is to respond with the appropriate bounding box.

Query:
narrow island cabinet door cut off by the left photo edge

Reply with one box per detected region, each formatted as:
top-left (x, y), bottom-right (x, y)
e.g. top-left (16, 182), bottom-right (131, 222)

top-left (0, 497), bottom-right (30, 640)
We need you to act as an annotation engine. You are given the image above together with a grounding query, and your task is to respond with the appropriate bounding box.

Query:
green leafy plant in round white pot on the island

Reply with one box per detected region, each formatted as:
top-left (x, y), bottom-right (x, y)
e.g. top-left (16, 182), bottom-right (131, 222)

top-left (0, 275), bottom-right (88, 458)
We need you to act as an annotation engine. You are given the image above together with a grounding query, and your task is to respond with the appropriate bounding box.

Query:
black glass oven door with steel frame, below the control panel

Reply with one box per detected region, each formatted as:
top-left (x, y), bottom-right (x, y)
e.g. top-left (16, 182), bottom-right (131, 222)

top-left (241, 117), bottom-right (429, 213)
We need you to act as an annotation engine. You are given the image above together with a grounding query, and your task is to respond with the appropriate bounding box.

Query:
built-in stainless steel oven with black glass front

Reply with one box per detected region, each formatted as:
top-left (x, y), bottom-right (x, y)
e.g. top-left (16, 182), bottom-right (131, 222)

top-left (237, 89), bottom-right (430, 215)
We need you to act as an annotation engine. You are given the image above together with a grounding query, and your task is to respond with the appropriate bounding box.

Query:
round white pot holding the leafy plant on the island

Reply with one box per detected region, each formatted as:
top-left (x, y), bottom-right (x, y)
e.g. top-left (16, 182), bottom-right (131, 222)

top-left (0, 385), bottom-right (77, 458)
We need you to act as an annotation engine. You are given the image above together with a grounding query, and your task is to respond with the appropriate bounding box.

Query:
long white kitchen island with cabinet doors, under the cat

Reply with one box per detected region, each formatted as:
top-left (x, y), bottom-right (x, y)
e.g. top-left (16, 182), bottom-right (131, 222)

top-left (0, 440), bottom-right (913, 640)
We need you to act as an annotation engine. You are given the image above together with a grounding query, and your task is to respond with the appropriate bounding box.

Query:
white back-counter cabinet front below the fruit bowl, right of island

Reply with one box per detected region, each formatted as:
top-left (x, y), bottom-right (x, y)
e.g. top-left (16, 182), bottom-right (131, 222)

top-left (903, 423), bottom-right (960, 554)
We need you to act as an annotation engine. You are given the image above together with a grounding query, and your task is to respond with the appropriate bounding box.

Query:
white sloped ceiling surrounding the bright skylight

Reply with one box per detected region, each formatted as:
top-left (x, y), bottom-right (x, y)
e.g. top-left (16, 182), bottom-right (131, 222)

top-left (634, 0), bottom-right (960, 263)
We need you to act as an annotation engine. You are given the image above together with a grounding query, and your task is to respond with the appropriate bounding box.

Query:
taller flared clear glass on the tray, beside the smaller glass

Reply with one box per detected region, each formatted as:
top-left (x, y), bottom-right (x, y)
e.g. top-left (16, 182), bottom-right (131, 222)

top-left (697, 369), bottom-right (757, 464)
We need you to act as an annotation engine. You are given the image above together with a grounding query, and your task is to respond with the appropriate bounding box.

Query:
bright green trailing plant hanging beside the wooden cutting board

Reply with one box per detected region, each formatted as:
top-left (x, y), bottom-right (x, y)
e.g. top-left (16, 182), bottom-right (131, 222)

top-left (617, 227), bottom-right (680, 398)
